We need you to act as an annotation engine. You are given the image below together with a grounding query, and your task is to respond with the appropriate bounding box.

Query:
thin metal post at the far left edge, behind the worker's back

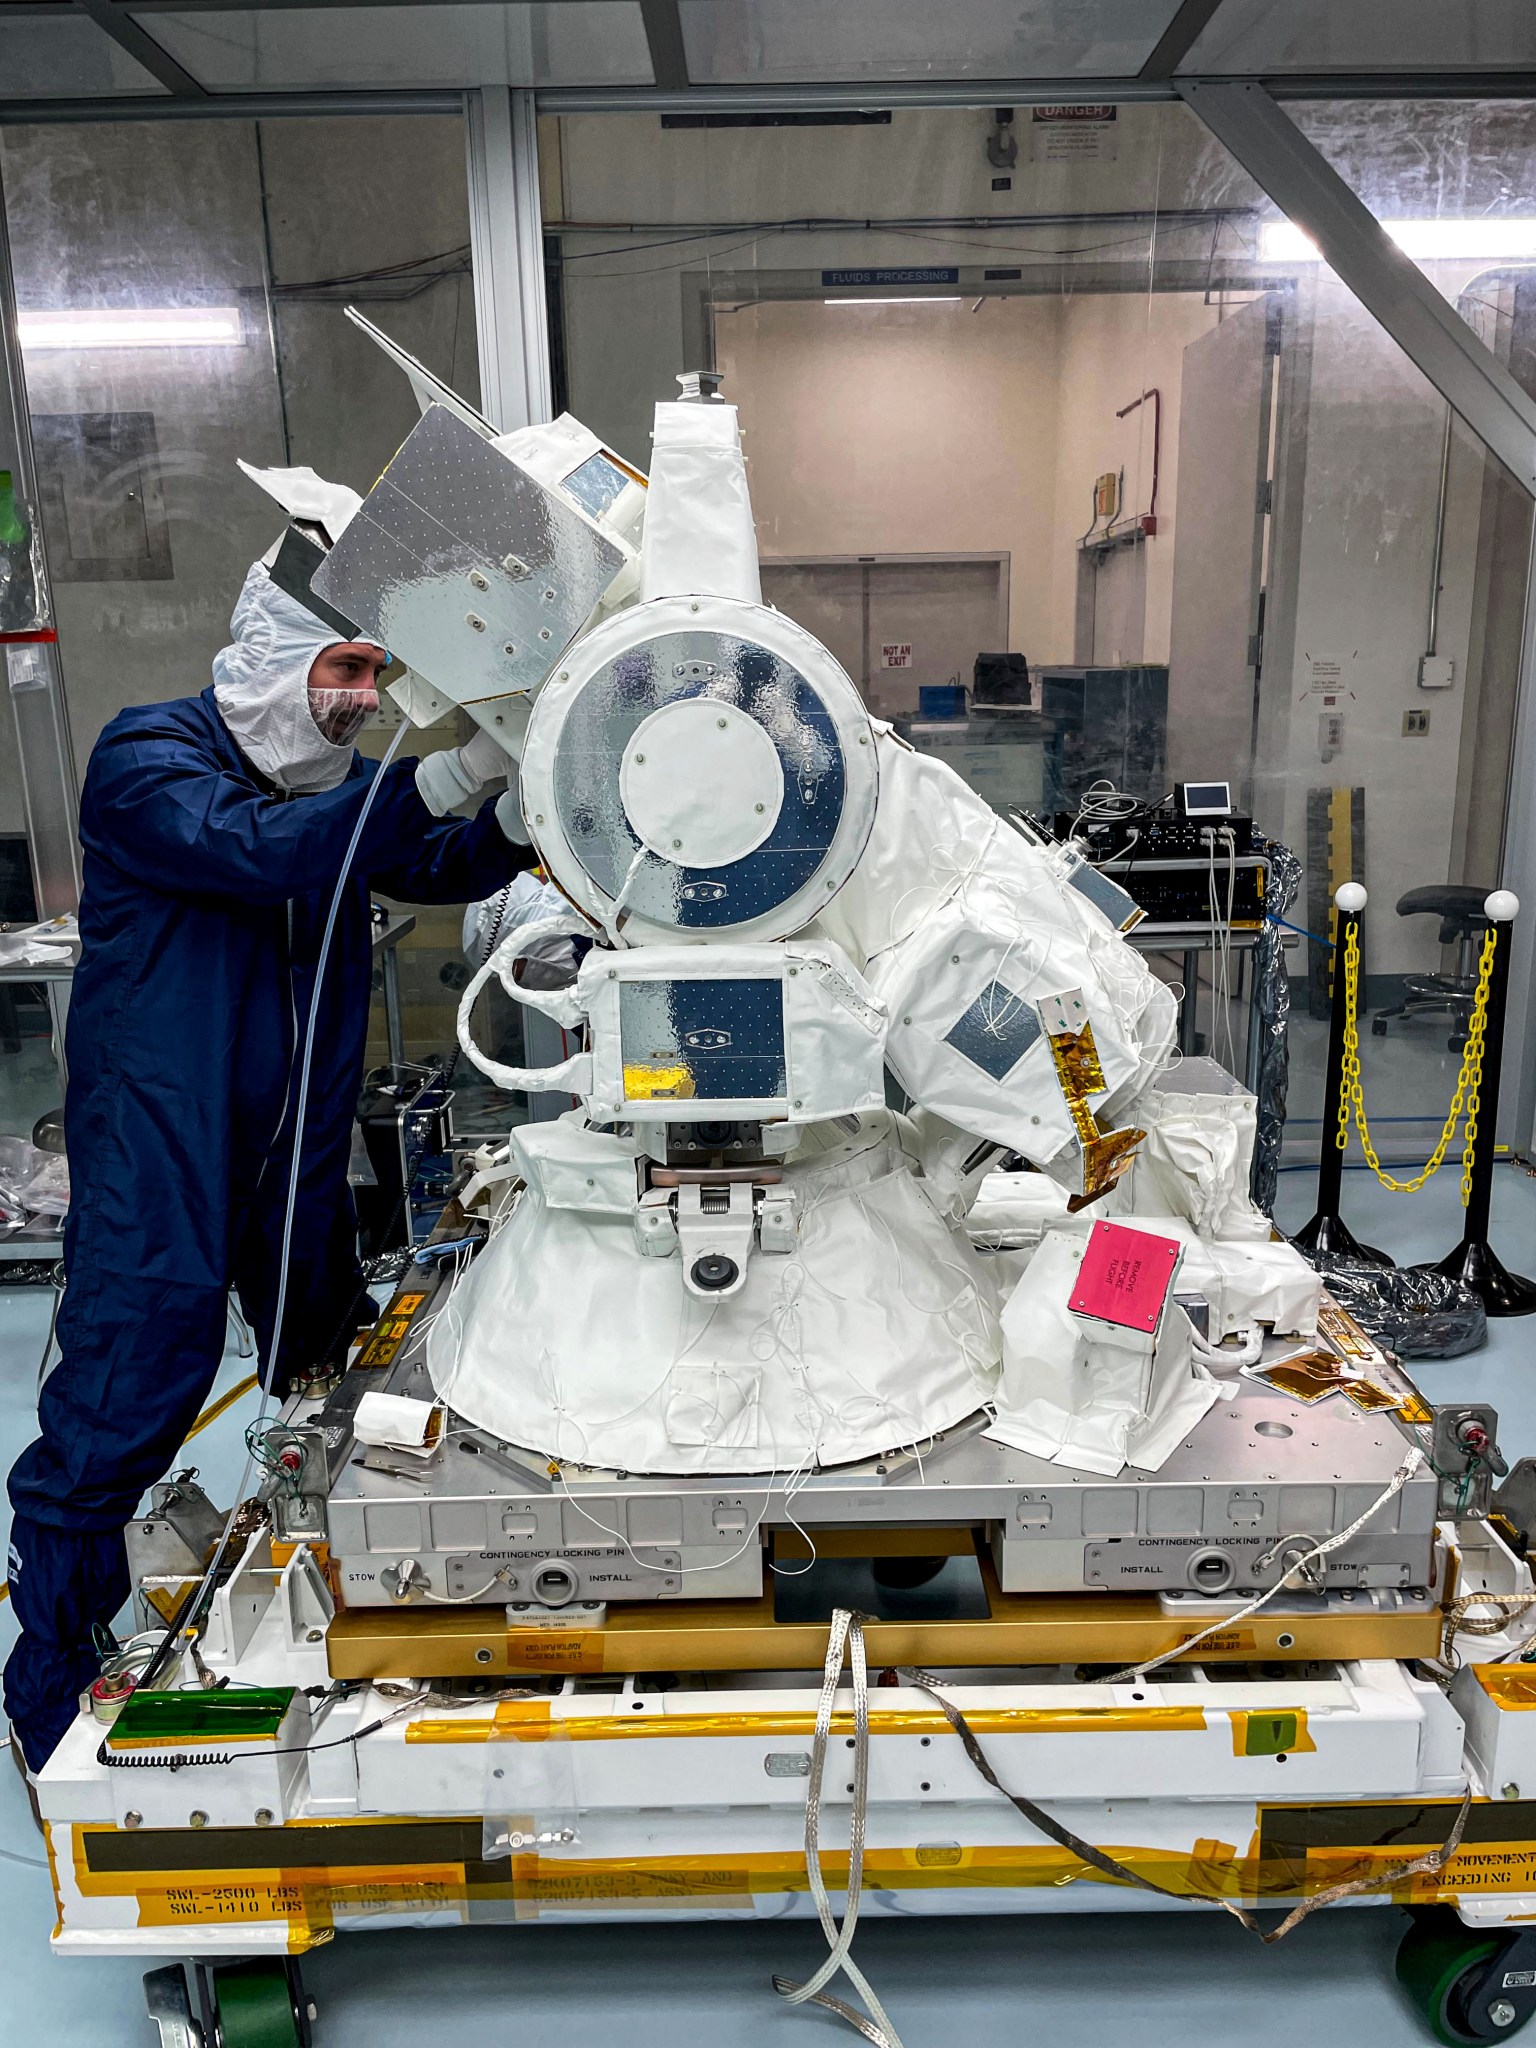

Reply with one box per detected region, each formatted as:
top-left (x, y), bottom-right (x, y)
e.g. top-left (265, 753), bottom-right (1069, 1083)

top-left (0, 146), bottom-right (80, 918)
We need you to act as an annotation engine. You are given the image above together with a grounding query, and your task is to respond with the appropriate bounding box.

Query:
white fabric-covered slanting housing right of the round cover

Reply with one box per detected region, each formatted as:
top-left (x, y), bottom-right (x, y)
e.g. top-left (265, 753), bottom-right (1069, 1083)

top-left (817, 727), bottom-right (1176, 1178)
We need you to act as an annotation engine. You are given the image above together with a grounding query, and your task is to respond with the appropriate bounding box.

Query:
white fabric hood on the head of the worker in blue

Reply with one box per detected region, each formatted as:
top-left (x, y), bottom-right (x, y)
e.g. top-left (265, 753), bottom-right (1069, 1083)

top-left (213, 561), bottom-right (382, 797)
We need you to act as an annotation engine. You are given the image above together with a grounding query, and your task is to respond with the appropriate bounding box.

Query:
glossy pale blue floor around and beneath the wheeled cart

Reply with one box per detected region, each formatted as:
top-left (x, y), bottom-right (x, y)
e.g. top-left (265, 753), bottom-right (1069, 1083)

top-left (0, 1165), bottom-right (1536, 2048)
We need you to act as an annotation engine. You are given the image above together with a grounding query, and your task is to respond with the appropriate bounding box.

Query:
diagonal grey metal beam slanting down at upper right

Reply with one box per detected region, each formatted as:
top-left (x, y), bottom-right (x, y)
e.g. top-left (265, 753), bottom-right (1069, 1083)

top-left (1176, 80), bottom-right (1536, 498)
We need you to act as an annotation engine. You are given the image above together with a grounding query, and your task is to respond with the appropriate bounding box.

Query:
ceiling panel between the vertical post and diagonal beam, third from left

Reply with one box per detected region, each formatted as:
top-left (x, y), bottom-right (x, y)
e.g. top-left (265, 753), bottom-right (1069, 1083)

top-left (680, 0), bottom-right (1176, 84)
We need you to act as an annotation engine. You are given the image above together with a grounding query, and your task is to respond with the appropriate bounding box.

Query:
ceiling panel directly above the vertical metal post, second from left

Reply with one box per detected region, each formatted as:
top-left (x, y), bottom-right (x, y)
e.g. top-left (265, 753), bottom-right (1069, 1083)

top-left (137, 0), bottom-right (651, 92)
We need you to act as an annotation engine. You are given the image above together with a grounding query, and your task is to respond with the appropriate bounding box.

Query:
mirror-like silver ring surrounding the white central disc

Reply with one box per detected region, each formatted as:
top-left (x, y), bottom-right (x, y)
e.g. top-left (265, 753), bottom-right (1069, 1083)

top-left (555, 631), bottom-right (846, 932)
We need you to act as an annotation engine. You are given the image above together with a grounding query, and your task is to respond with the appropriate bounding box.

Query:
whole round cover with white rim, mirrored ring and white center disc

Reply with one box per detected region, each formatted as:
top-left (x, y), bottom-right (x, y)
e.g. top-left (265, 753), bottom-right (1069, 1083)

top-left (522, 598), bottom-right (877, 938)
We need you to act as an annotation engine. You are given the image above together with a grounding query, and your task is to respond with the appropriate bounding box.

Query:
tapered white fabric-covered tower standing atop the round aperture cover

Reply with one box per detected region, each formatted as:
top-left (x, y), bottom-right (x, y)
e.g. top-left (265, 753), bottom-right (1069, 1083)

top-left (641, 401), bottom-right (762, 604)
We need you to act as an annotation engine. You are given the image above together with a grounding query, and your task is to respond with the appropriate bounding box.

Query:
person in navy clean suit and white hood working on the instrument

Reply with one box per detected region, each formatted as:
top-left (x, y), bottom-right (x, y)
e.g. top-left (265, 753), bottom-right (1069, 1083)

top-left (4, 563), bottom-right (535, 1772)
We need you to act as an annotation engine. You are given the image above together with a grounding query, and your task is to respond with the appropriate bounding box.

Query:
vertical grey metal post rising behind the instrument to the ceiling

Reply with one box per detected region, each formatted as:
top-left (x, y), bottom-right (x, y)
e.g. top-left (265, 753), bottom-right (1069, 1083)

top-left (465, 86), bottom-right (553, 434)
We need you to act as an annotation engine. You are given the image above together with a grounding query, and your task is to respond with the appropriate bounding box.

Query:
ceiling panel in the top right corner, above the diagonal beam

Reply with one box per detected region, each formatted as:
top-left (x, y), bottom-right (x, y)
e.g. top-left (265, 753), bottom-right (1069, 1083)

top-left (1180, 0), bottom-right (1536, 72)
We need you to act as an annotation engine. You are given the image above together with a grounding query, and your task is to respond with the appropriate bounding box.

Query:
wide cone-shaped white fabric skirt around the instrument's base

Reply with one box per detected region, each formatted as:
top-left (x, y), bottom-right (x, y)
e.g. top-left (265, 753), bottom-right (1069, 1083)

top-left (426, 1112), bottom-right (997, 1473)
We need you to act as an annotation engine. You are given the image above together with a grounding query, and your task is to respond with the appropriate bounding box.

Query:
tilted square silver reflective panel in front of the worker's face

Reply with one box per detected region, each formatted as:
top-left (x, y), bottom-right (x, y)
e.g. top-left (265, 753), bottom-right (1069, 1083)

top-left (313, 406), bottom-right (625, 705)
